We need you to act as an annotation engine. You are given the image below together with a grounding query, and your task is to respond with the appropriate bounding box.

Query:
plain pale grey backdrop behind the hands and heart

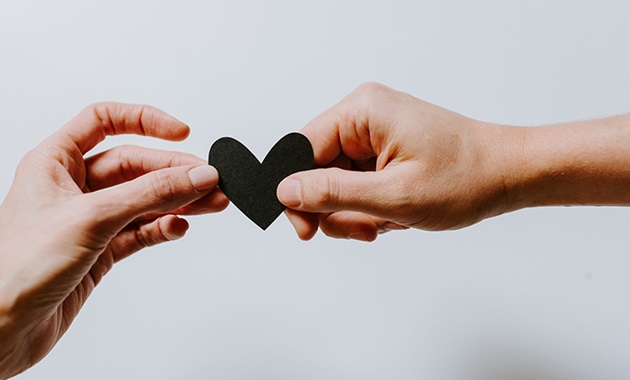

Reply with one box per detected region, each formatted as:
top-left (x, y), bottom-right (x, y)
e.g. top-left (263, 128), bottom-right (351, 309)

top-left (0, 0), bottom-right (630, 380)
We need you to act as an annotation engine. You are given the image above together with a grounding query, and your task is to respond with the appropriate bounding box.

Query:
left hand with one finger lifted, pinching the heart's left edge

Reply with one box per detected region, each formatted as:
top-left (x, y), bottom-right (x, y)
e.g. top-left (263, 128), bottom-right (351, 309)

top-left (0, 104), bottom-right (228, 378)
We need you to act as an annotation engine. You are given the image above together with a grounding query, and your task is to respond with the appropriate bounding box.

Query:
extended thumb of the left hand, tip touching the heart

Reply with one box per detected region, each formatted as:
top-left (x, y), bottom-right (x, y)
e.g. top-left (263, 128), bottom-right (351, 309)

top-left (88, 165), bottom-right (219, 226)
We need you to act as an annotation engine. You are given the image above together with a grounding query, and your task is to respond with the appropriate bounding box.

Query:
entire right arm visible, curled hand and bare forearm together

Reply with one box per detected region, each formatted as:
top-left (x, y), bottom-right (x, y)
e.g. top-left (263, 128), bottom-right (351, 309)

top-left (277, 83), bottom-right (630, 241)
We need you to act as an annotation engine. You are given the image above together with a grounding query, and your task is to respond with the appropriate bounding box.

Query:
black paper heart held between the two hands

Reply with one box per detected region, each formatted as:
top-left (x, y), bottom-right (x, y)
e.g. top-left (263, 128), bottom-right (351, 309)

top-left (208, 133), bottom-right (313, 230)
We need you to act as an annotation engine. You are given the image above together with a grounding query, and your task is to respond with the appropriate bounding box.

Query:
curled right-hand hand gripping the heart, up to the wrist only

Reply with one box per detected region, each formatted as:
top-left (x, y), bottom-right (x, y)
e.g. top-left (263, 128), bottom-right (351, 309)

top-left (277, 83), bottom-right (521, 241)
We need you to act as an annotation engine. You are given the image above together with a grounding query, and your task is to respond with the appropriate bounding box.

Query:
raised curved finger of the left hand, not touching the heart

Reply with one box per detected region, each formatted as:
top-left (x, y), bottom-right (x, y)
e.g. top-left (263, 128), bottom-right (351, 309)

top-left (56, 103), bottom-right (190, 154)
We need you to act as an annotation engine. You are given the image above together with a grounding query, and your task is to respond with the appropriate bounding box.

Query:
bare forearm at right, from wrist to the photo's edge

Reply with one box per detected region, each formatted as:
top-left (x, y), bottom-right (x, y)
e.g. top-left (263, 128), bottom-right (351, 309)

top-left (504, 115), bottom-right (630, 209)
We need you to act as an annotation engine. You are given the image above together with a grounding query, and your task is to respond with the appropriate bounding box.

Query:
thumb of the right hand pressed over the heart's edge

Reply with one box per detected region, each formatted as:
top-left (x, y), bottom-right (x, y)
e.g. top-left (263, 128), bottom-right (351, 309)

top-left (277, 168), bottom-right (397, 216)
